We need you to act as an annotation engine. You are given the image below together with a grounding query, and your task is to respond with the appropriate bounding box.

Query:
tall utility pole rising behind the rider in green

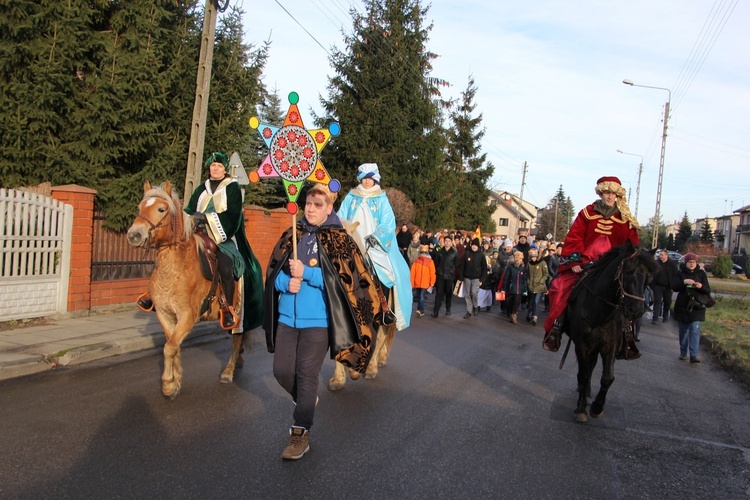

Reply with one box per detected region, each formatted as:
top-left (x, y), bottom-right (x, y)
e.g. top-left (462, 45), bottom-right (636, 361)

top-left (183, 0), bottom-right (217, 203)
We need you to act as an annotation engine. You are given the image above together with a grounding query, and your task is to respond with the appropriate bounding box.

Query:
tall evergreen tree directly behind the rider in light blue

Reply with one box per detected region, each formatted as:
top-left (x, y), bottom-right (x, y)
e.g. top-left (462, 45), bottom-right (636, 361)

top-left (317, 0), bottom-right (447, 226)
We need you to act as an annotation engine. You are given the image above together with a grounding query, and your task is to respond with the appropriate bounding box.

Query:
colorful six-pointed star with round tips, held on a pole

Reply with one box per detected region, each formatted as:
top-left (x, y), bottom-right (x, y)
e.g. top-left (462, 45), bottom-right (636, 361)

top-left (248, 92), bottom-right (341, 215)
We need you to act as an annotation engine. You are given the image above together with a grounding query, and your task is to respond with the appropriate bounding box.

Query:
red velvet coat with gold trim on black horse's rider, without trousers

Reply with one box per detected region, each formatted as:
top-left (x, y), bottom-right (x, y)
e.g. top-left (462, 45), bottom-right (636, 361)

top-left (558, 203), bottom-right (639, 272)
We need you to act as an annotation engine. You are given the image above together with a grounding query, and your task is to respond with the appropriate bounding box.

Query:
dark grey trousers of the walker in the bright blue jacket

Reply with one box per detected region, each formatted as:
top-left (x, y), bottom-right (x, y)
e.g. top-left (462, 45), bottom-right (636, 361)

top-left (273, 323), bottom-right (328, 429)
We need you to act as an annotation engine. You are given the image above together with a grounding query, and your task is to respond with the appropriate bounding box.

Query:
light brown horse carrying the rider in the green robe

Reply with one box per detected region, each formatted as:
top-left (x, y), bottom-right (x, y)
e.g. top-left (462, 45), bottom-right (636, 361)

top-left (128, 181), bottom-right (245, 398)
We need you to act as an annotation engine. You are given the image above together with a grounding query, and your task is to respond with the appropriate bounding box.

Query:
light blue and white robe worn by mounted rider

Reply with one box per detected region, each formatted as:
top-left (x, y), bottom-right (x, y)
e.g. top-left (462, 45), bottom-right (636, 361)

top-left (337, 185), bottom-right (412, 330)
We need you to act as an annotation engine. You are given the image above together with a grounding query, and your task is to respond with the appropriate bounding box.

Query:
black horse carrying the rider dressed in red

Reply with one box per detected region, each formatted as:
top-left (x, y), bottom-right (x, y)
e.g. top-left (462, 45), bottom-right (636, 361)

top-left (563, 241), bottom-right (657, 422)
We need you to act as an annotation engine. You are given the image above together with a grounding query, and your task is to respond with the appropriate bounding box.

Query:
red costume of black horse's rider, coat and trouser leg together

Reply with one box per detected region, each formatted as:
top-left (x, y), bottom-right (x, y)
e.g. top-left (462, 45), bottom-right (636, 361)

top-left (544, 203), bottom-right (639, 332)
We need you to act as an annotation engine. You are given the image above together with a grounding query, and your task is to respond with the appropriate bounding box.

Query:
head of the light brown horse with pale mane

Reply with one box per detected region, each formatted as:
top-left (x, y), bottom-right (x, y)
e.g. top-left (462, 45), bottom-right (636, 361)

top-left (128, 181), bottom-right (189, 248)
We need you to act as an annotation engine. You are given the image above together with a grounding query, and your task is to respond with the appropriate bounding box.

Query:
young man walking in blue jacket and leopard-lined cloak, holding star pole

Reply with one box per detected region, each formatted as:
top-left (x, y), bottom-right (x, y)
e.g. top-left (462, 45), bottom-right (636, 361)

top-left (263, 184), bottom-right (382, 460)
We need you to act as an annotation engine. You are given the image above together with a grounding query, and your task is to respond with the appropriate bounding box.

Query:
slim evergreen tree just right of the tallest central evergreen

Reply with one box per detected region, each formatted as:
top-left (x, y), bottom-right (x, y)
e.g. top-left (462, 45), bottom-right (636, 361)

top-left (450, 77), bottom-right (497, 233)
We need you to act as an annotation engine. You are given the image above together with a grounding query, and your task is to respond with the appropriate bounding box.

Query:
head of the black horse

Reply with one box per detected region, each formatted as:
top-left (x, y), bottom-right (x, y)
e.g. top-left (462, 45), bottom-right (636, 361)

top-left (619, 241), bottom-right (658, 321)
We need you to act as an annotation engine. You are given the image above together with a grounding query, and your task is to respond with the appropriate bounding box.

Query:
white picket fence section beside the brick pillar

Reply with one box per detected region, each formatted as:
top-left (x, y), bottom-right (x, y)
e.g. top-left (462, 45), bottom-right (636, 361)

top-left (0, 189), bottom-right (73, 321)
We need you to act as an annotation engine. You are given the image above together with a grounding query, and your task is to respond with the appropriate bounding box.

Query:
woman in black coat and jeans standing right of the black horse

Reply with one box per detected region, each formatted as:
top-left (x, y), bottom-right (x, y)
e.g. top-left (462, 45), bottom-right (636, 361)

top-left (673, 253), bottom-right (711, 363)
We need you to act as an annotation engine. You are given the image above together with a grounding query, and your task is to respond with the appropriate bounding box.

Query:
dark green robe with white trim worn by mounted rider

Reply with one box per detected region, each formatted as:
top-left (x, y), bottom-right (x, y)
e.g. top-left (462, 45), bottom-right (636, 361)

top-left (185, 178), bottom-right (263, 331)
